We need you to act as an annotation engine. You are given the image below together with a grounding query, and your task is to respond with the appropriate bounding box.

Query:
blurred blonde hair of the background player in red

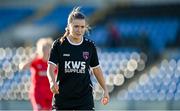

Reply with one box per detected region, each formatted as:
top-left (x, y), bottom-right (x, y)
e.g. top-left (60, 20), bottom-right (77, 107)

top-left (36, 37), bottom-right (53, 55)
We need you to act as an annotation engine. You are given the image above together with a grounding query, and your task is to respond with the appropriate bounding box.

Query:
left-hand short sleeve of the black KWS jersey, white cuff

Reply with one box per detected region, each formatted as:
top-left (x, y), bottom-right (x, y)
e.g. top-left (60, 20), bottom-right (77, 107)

top-left (48, 40), bottom-right (59, 65)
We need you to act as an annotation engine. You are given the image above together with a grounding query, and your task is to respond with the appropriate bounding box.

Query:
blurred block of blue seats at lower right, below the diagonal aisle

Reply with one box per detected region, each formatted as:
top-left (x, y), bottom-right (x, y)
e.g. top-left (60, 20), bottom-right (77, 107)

top-left (117, 59), bottom-right (180, 101)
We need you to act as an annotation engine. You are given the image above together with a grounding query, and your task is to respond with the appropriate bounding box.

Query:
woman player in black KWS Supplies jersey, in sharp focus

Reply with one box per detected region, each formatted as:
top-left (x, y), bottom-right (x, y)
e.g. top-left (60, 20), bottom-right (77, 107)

top-left (47, 7), bottom-right (109, 110)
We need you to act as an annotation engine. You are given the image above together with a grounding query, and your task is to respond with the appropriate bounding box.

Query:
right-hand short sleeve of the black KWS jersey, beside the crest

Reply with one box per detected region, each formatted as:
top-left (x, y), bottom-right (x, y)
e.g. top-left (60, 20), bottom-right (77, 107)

top-left (90, 44), bottom-right (99, 68)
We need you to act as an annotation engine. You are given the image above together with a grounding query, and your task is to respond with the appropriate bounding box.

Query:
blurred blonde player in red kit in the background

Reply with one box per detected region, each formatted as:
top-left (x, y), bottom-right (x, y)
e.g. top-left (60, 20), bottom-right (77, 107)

top-left (19, 38), bottom-right (56, 111)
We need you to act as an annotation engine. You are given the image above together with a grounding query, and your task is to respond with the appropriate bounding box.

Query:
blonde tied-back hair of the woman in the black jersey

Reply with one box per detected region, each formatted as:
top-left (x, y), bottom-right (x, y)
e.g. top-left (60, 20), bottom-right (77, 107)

top-left (60, 7), bottom-right (90, 44)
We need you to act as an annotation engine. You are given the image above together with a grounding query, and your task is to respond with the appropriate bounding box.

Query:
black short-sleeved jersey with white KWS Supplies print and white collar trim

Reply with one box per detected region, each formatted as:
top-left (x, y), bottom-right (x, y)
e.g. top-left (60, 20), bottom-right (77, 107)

top-left (49, 38), bottom-right (99, 107)
